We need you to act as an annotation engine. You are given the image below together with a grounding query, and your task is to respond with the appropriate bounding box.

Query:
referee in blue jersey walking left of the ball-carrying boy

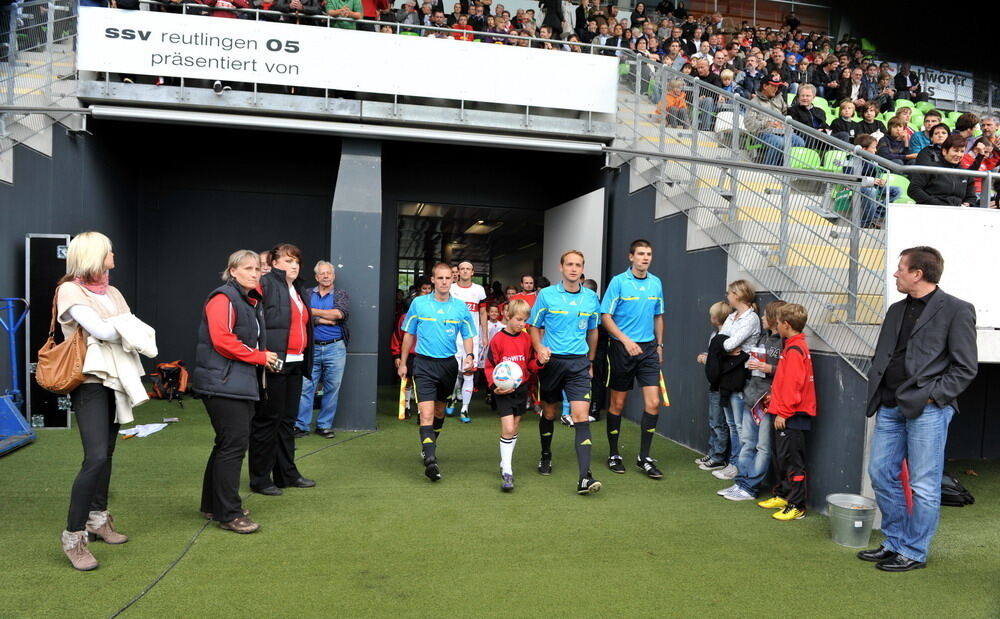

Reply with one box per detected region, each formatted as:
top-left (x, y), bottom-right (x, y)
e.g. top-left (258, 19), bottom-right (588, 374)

top-left (399, 262), bottom-right (476, 481)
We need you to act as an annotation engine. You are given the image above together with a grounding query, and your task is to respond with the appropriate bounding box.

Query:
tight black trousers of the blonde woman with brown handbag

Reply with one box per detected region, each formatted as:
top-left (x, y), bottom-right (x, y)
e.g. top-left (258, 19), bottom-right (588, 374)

top-left (66, 383), bottom-right (120, 531)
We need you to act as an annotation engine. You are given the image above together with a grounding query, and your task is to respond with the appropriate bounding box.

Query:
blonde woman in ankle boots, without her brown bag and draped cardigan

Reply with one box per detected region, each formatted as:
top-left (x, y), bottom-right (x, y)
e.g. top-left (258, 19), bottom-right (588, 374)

top-left (56, 232), bottom-right (144, 571)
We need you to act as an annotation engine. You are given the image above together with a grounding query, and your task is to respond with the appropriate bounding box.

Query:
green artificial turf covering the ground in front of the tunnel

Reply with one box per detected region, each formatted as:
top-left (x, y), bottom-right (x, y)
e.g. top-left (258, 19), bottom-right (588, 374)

top-left (0, 392), bottom-right (1000, 618)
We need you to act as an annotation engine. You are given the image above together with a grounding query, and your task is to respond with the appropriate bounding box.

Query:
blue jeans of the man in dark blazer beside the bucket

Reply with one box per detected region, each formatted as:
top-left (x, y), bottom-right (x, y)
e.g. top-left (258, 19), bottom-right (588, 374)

top-left (868, 404), bottom-right (955, 561)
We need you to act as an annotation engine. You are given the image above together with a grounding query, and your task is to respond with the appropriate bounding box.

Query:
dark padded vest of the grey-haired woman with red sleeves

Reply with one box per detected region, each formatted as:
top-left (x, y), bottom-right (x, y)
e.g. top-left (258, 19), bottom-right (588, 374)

top-left (191, 281), bottom-right (267, 401)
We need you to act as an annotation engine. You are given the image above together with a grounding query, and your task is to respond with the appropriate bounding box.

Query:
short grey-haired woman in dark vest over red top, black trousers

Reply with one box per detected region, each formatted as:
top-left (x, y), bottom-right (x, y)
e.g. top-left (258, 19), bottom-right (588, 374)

top-left (191, 249), bottom-right (278, 533)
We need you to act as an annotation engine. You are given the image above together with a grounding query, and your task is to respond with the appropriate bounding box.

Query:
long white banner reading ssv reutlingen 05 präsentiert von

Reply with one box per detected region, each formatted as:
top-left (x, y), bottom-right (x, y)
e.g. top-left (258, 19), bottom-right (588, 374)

top-left (77, 6), bottom-right (618, 114)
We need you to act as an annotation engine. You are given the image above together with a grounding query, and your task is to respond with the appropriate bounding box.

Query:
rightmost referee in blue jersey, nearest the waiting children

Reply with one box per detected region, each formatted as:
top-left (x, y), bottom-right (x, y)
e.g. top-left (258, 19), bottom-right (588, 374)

top-left (601, 239), bottom-right (663, 479)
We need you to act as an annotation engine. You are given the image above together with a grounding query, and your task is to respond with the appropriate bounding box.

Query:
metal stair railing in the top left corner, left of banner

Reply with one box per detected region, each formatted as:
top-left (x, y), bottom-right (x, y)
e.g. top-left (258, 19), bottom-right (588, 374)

top-left (0, 0), bottom-right (76, 153)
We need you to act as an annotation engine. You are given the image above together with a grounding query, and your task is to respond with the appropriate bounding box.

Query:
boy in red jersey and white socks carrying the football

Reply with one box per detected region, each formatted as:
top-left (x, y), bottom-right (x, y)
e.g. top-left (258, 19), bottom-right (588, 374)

top-left (486, 299), bottom-right (539, 492)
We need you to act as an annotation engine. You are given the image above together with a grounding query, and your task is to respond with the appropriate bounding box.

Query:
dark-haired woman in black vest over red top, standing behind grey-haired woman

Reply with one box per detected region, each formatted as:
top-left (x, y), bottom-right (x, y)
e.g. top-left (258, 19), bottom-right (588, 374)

top-left (250, 243), bottom-right (316, 496)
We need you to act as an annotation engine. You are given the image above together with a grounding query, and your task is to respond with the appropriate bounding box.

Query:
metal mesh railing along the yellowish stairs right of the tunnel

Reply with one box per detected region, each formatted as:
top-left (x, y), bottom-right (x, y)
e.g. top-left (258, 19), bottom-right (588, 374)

top-left (618, 54), bottom-right (991, 376)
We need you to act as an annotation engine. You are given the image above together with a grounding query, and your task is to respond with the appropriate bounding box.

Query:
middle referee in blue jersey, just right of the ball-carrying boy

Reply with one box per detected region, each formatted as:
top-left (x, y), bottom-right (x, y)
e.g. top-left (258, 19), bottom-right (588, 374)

top-left (528, 250), bottom-right (601, 494)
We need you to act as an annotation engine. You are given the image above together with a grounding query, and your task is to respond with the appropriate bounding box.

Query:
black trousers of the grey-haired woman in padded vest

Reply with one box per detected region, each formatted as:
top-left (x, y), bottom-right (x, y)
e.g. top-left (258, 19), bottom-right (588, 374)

top-left (201, 397), bottom-right (254, 522)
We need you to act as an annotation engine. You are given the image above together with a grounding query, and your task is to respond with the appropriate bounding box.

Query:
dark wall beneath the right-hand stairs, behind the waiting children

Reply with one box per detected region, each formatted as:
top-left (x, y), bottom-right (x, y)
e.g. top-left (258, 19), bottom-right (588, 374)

top-left (607, 166), bottom-right (867, 509)
